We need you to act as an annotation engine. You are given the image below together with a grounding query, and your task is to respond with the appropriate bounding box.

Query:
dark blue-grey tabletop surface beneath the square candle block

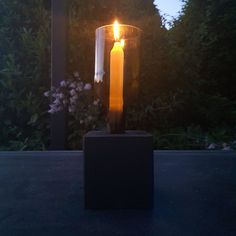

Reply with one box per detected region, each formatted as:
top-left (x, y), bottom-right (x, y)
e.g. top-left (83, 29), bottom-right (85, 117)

top-left (0, 151), bottom-right (236, 236)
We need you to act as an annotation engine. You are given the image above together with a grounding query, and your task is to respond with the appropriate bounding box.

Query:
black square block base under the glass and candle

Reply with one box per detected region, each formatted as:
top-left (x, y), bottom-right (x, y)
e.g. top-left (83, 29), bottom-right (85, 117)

top-left (84, 131), bottom-right (154, 209)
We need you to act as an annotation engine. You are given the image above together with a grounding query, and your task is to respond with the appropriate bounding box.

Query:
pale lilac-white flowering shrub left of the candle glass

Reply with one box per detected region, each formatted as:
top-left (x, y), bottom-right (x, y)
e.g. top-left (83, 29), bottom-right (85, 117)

top-left (44, 72), bottom-right (101, 148)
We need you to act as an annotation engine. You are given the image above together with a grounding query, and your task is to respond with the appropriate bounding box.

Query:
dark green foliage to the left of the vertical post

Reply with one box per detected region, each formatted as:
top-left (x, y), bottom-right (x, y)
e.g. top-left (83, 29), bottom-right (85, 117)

top-left (0, 0), bottom-right (49, 150)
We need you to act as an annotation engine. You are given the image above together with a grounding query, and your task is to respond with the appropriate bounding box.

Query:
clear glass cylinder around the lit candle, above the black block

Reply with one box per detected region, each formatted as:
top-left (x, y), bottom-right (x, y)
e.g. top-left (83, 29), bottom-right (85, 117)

top-left (94, 22), bottom-right (141, 133)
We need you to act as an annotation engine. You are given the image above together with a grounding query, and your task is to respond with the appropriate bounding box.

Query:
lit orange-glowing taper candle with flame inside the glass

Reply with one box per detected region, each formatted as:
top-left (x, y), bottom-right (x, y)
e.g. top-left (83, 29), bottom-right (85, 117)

top-left (109, 21), bottom-right (124, 123)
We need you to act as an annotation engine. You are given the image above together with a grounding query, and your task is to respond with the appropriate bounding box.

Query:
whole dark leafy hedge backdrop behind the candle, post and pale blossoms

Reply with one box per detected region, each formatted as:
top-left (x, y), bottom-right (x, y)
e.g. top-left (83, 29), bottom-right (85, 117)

top-left (0, 0), bottom-right (236, 150)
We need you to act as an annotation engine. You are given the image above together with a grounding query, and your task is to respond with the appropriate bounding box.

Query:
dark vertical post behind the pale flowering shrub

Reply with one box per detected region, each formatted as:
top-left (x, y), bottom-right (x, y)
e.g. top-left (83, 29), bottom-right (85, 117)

top-left (50, 0), bottom-right (67, 150)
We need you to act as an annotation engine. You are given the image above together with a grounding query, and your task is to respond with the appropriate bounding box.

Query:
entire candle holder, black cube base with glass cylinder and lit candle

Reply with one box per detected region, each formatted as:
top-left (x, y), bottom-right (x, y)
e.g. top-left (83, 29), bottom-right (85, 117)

top-left (83, 22), bottom-right (154, 209)
